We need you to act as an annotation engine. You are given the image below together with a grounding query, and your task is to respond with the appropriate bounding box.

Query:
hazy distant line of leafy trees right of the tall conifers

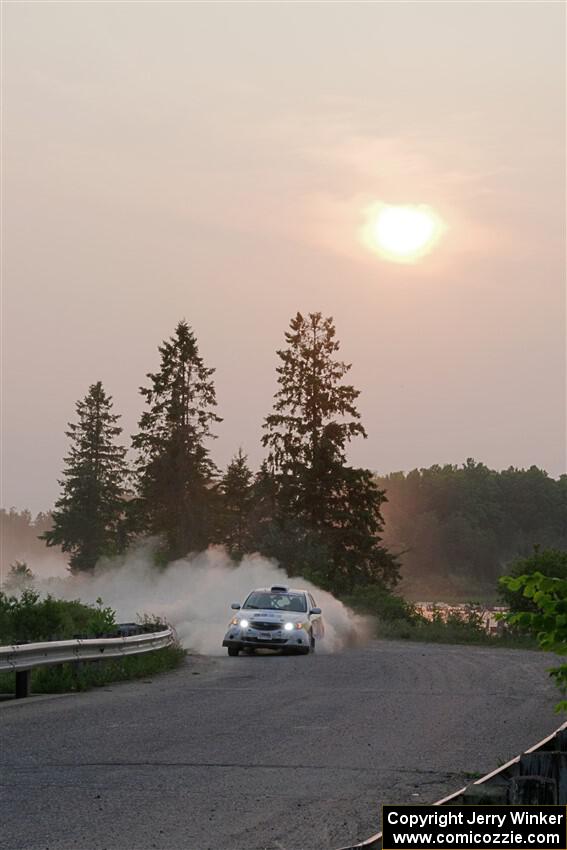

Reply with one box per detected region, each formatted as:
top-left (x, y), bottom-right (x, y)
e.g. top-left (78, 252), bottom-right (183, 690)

top-left (377, 459), bottom-right (567, 600)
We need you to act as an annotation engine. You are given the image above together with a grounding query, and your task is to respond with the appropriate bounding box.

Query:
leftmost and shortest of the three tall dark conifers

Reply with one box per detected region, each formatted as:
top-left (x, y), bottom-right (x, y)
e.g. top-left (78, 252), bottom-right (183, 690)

top-left (41, 381), bottom-right (127, 573)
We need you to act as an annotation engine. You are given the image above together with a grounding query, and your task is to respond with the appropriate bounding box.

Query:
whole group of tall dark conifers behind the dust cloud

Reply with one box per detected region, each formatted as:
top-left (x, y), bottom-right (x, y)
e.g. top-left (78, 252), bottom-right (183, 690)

top-left (42, 313), bottom-right (399, 593)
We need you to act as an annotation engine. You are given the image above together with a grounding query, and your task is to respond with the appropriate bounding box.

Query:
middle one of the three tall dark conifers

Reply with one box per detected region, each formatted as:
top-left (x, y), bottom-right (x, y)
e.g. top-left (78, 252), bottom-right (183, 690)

top-left (132, 321), bottom-right (222, 559)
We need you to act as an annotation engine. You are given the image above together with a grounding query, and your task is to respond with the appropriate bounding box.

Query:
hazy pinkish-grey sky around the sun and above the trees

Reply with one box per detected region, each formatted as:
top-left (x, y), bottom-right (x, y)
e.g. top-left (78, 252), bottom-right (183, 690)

top-left (2, 0), bottom-right (566, 510)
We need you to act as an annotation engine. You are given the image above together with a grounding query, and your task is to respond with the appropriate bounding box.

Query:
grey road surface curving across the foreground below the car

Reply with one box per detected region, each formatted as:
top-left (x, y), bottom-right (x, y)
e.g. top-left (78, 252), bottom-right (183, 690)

top-left (0, 641), bottom-right (560, 850)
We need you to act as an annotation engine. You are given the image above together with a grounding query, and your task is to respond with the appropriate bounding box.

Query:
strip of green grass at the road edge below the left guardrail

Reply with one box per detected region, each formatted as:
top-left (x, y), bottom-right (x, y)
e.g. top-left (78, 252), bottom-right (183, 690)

top-left (0, 644), bottom-right (187, 694)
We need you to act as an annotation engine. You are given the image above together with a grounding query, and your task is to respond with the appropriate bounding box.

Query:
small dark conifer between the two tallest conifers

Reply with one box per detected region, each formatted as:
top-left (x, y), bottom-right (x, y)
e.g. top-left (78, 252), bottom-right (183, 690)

top-left (220, 449), bottom-right (254, 560)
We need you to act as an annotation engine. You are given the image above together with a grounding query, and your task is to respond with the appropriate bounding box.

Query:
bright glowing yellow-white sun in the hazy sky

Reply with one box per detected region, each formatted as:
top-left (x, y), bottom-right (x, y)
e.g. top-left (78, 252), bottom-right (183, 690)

top-left (363, 204), bottom-right (444, 263)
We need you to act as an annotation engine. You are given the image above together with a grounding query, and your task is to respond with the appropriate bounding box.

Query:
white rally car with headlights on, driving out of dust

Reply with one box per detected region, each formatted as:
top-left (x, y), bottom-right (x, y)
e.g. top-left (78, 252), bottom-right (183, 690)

top-left (222, 585), bottom-right (325, 655)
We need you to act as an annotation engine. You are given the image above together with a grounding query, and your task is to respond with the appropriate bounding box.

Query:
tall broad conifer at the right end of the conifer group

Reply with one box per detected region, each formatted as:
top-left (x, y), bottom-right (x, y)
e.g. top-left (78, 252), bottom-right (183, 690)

top-left (263, 313), bottom-right (398, 592)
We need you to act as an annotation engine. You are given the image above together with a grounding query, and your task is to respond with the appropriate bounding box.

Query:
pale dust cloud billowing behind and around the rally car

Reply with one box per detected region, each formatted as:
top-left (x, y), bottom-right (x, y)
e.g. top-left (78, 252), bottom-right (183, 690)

top-left (36, 543), bottom-right (370, 655)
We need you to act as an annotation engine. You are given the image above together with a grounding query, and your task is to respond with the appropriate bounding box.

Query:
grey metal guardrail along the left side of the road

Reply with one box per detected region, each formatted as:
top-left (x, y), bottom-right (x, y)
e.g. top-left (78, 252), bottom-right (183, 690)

top-left (0, 628), bottom-right (175, 698)
